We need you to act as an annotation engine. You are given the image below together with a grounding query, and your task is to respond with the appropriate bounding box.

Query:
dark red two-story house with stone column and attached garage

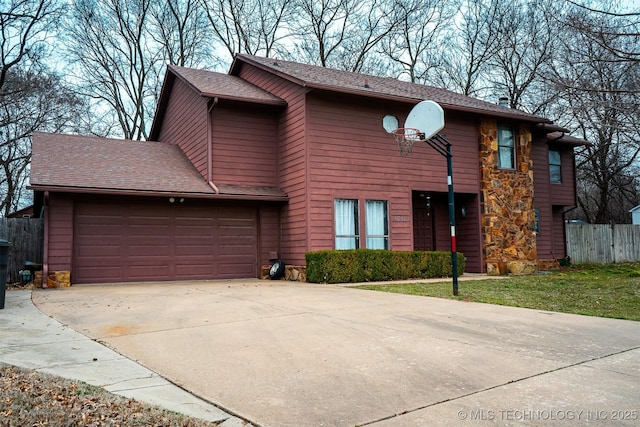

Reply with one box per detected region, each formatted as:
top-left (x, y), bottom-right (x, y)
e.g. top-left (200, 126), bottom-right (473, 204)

top-left (30, 55), bottom-right (584, 283)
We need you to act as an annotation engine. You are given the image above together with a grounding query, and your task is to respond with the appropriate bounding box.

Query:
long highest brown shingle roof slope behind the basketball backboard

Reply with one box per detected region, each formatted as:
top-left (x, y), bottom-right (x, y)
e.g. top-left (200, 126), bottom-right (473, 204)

top-left (229, 54), bottom-right (550, 123)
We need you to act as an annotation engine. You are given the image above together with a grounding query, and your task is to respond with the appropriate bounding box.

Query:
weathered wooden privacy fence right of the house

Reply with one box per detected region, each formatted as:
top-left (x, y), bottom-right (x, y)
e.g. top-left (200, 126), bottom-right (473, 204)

top-left (565, 224), bottom-right (640, 264)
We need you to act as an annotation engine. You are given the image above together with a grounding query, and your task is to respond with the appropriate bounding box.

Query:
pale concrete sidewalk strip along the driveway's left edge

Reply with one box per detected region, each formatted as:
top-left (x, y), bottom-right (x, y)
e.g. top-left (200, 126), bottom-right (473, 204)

top-left (0, 290), bottom-right (248, 427)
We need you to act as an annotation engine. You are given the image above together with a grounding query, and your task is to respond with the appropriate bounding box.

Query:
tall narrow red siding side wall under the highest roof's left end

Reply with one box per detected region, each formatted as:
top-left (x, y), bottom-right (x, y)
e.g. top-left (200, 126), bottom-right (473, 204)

top-left (240, 65), bottom-right (311, 264)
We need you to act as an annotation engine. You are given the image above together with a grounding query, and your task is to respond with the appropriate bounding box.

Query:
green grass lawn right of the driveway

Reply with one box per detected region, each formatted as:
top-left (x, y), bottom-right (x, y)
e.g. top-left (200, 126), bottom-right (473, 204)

top-left (358, 263), bottom-right (640, 321)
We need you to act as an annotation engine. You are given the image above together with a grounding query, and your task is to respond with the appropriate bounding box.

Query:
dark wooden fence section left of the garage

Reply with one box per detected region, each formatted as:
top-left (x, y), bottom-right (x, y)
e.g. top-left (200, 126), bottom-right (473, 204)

top-left (0, 218), bottom-right (44, 283)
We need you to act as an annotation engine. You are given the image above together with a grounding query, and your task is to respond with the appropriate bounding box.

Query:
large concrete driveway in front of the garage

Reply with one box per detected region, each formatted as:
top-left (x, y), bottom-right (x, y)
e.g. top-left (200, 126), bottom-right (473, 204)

top-left (33, 280), bottom-right (640, 427)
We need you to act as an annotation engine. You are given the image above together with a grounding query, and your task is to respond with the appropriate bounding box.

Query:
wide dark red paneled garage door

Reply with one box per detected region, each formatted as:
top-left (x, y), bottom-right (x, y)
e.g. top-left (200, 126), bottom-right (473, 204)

top-left (72, 203), bottom-right (257, 283)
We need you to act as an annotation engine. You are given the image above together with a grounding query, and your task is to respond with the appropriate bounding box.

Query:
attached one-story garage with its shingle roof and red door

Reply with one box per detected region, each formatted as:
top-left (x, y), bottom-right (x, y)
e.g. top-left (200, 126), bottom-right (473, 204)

top-left (31, 133), bottom-right (288, 284)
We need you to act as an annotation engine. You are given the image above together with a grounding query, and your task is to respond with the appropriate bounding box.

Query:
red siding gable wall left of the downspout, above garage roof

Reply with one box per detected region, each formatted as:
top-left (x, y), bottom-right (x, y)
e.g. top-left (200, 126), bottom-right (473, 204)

top-left (158, 78), bottom-right (207, 178)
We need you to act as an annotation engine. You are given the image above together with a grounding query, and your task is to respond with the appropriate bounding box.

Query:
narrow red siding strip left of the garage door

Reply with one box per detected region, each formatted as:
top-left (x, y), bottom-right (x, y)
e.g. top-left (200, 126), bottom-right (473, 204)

top-left (46, 193), bottom-right (73, 271)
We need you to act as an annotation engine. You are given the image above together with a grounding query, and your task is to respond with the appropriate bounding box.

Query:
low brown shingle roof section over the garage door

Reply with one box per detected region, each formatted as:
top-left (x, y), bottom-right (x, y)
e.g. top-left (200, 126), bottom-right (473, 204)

top-left (29, 132), bottom-right (287, 200)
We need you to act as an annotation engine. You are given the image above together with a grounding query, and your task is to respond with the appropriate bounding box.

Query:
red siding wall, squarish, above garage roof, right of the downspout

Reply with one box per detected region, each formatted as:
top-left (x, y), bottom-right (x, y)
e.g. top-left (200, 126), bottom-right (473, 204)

top-left (211, 105), bottom-right (278, 186)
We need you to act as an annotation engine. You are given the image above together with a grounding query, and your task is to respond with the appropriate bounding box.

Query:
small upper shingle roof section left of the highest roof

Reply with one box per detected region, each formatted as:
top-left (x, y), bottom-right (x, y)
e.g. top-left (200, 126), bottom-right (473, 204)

top-left (169, 65), bottom-right (286, 105)
